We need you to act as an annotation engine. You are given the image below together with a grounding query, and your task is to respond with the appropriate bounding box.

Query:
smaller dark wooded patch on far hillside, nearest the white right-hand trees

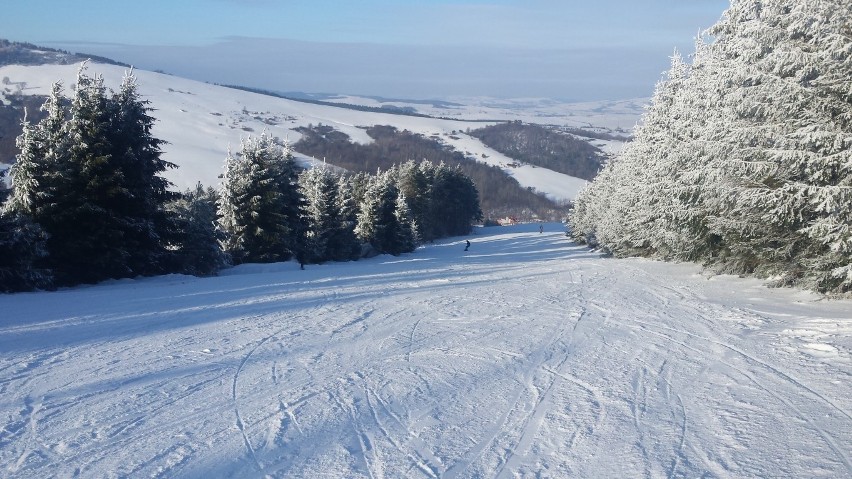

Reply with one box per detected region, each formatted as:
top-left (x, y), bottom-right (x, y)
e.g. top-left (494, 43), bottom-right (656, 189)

top-left (470, 121), bottom-right (605, 180)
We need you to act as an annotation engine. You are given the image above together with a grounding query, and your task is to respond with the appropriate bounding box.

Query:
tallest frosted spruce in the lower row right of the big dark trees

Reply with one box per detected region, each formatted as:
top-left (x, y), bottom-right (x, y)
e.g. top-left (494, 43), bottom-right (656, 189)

top-left (219, 132), bottom-right (303, 264)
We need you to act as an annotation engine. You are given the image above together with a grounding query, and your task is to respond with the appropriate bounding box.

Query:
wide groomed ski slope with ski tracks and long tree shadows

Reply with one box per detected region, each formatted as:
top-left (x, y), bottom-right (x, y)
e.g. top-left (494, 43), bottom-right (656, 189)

top-left (0, 225), bottom-right (852, 479)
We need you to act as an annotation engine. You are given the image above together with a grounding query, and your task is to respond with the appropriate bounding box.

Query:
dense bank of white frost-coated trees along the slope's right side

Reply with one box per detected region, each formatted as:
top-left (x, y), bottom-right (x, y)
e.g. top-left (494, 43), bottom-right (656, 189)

top-left (570, 0), bottom-right (852, 294)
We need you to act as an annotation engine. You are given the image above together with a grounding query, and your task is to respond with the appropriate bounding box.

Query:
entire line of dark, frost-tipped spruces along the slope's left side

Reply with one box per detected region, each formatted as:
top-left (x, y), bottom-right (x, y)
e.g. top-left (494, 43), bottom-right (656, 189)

top-left (0, 66), bottom-right (481, 292)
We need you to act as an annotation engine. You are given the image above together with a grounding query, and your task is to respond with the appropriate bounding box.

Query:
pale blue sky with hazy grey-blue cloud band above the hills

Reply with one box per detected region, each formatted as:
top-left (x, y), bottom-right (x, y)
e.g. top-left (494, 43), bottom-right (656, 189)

top-left (0, 0), bottom-right (728, 100)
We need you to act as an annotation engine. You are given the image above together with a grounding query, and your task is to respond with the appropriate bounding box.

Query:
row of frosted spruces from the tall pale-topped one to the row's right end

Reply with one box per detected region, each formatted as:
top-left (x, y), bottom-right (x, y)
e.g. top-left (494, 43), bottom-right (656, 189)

top-left (219, 134), bottom-right (482, 265)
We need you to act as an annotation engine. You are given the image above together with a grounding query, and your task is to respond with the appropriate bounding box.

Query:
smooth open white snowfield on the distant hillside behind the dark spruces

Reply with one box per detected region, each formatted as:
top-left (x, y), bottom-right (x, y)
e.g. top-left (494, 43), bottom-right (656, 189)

top-left (0, 64), bottom-right (641, 200)
